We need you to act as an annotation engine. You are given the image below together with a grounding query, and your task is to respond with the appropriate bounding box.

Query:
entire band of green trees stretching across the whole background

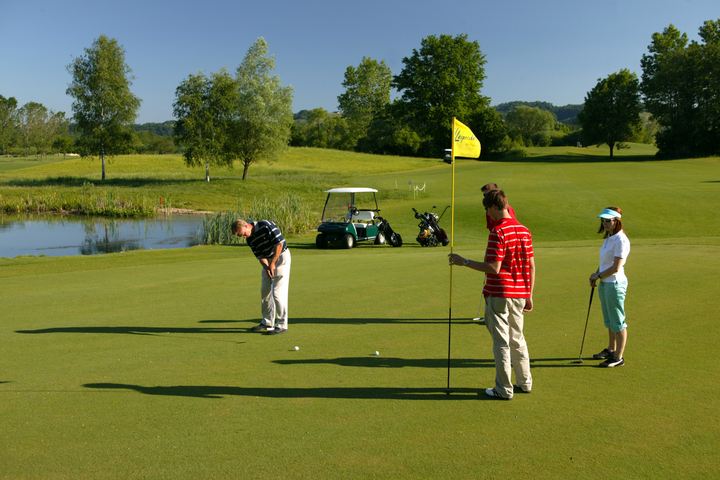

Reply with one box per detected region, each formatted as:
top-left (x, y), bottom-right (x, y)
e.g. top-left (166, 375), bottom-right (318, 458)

top-left (0, 20), bottom-right (720, 181)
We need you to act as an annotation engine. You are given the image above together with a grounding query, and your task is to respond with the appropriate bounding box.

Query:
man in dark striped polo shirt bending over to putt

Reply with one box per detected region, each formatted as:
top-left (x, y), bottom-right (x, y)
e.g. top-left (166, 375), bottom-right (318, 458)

top-left (232, 220), bottom-right (291, 335)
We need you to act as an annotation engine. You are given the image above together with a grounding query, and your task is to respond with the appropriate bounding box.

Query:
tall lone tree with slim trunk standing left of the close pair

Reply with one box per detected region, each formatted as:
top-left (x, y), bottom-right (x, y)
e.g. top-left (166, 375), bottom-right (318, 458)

top-left (66, 35), bottom-right (142, 180)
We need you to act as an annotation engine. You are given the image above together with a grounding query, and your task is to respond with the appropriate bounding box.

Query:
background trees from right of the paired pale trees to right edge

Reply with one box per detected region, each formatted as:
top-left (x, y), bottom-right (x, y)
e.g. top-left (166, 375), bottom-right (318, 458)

top-left (291, 21), bottom-right (720, 158)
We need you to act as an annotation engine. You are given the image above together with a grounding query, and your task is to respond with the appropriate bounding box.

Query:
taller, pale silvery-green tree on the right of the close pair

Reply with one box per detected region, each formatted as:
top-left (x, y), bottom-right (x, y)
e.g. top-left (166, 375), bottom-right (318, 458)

top-left (226, 37), bottom-right (293, 180)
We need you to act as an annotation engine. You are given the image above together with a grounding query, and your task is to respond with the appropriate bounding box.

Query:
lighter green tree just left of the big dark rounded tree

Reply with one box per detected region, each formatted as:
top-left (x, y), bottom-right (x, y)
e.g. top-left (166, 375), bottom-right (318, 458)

top-left (338, 57), bottom-right (392, 140)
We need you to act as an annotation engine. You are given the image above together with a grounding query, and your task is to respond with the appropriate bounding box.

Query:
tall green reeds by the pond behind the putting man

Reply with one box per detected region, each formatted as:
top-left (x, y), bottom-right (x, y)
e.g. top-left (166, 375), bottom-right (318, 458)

top-left (198, 192), bottom-right (317, 245)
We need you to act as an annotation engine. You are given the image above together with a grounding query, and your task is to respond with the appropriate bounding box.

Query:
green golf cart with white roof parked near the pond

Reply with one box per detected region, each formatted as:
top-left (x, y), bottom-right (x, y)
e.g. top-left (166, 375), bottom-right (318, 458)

top-left (315, 188), bottom-right (402, 248)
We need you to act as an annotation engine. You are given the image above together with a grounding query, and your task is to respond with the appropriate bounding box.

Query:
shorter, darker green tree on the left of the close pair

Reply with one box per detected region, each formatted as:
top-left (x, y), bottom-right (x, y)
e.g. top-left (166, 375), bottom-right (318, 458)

top-left (173, 68), bottom-right (237, 182)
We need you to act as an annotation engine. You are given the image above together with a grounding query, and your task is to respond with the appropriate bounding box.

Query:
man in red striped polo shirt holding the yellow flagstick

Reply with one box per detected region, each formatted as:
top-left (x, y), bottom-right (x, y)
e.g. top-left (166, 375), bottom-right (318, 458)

top-left (450, 190), bottom-right (535, 400)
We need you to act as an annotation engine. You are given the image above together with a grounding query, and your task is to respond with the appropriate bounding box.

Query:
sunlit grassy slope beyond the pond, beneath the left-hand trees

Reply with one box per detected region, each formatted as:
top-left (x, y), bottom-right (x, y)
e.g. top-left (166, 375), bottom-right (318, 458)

top-left (0, 148), bottom-right (438, 210)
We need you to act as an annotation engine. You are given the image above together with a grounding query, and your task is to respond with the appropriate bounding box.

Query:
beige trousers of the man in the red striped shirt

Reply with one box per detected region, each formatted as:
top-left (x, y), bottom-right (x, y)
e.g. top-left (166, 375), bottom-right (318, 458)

top-left (485, 297), bottom-right (532, 397)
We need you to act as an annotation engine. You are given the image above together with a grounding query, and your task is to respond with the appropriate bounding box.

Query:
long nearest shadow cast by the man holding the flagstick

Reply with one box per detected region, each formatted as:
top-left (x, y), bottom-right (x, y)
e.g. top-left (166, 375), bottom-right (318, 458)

top-left (83, 383), bottom-right (484, 400)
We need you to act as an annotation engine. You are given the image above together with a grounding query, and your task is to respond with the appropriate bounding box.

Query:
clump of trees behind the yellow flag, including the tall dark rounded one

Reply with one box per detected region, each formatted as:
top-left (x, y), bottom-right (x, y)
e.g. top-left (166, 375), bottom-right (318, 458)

top-left (291, 34), bottom-right (505, 158)
